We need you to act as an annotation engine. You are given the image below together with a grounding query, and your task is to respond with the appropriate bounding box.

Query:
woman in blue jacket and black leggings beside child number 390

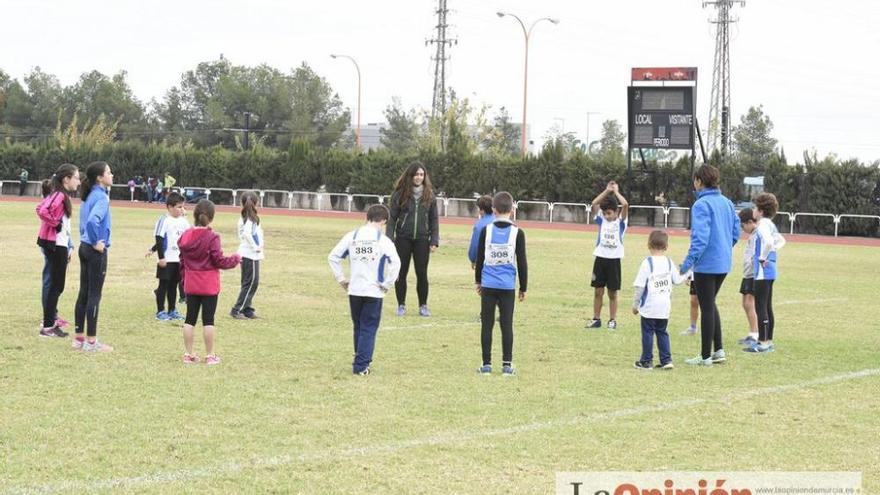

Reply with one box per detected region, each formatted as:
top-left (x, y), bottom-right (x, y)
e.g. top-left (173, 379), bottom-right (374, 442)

top-left (681, 165), bottom-right (740, 366)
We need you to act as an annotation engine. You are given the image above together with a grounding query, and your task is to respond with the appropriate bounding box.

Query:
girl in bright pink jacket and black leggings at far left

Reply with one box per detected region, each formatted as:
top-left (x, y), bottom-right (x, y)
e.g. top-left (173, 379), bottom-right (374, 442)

top-left (37, 163), bottom-right (79, 337)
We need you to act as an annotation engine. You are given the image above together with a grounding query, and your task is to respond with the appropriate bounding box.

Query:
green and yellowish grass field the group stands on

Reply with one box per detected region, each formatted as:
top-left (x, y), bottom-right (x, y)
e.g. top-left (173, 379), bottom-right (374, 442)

top-left (0, 203), bottom-right (880, 494)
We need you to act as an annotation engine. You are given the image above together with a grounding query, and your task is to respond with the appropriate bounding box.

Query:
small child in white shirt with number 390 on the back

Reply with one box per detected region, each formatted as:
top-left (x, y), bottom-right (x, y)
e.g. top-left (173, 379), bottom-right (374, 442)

top-left (633, 230), bottom-right (688, 370)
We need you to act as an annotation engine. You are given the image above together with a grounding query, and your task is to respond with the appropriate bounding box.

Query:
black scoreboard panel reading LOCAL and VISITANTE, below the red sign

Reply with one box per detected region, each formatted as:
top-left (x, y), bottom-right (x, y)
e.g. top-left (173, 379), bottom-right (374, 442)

top-left (627, 86), bottom-right (694, 150)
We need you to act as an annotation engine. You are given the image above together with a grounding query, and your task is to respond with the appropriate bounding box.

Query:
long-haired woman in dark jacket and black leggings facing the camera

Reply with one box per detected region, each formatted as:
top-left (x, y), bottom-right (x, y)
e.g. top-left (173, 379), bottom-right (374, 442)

top-left (385, 162), bottom-right (440, 316)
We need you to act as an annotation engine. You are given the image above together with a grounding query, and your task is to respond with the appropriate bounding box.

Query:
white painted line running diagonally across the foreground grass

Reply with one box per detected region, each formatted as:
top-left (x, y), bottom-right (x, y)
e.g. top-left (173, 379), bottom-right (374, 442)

top-left (3, 368), bottom-right (880, 495)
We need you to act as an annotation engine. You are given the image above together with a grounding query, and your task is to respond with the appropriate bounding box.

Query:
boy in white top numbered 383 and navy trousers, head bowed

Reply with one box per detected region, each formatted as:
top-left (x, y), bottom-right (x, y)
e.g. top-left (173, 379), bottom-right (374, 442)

top-left (327, 205), bottom-right (400, 375)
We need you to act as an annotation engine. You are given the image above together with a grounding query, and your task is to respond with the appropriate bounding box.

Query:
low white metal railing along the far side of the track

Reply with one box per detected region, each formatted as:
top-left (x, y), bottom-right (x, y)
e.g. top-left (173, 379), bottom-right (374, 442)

top-left (0, 180), bottom-right (880, 237)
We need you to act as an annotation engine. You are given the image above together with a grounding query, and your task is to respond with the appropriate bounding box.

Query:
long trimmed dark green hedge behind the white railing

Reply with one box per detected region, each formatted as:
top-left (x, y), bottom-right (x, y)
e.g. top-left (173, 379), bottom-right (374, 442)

top-left (0, 142), bottom-right (880, 236)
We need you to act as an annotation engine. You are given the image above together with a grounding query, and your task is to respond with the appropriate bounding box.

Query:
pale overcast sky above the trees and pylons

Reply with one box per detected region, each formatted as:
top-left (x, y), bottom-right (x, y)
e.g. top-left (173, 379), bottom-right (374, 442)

top-left (0, 0), bottom-right (880, 162)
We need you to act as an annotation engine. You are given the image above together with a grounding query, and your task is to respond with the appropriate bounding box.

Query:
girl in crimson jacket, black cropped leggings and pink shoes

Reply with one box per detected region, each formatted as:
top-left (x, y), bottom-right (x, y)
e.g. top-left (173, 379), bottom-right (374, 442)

top-left (177, 199), bottom-right (241, 365)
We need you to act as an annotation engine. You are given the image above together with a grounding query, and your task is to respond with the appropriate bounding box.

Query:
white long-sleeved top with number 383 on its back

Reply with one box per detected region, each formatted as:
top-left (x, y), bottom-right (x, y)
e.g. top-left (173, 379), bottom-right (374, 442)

top-left (327, 225), bottom-right (400, 299)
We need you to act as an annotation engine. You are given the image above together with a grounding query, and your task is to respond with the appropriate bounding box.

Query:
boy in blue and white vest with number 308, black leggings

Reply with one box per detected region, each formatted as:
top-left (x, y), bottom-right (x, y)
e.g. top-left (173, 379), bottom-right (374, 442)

top-left (474, 192), bottom-right (529, 376)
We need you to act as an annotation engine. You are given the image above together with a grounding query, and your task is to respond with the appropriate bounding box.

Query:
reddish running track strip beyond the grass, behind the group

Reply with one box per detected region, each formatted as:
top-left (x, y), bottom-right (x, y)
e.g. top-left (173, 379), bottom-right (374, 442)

top-left (0, 196), bottom-right (880, 247)
